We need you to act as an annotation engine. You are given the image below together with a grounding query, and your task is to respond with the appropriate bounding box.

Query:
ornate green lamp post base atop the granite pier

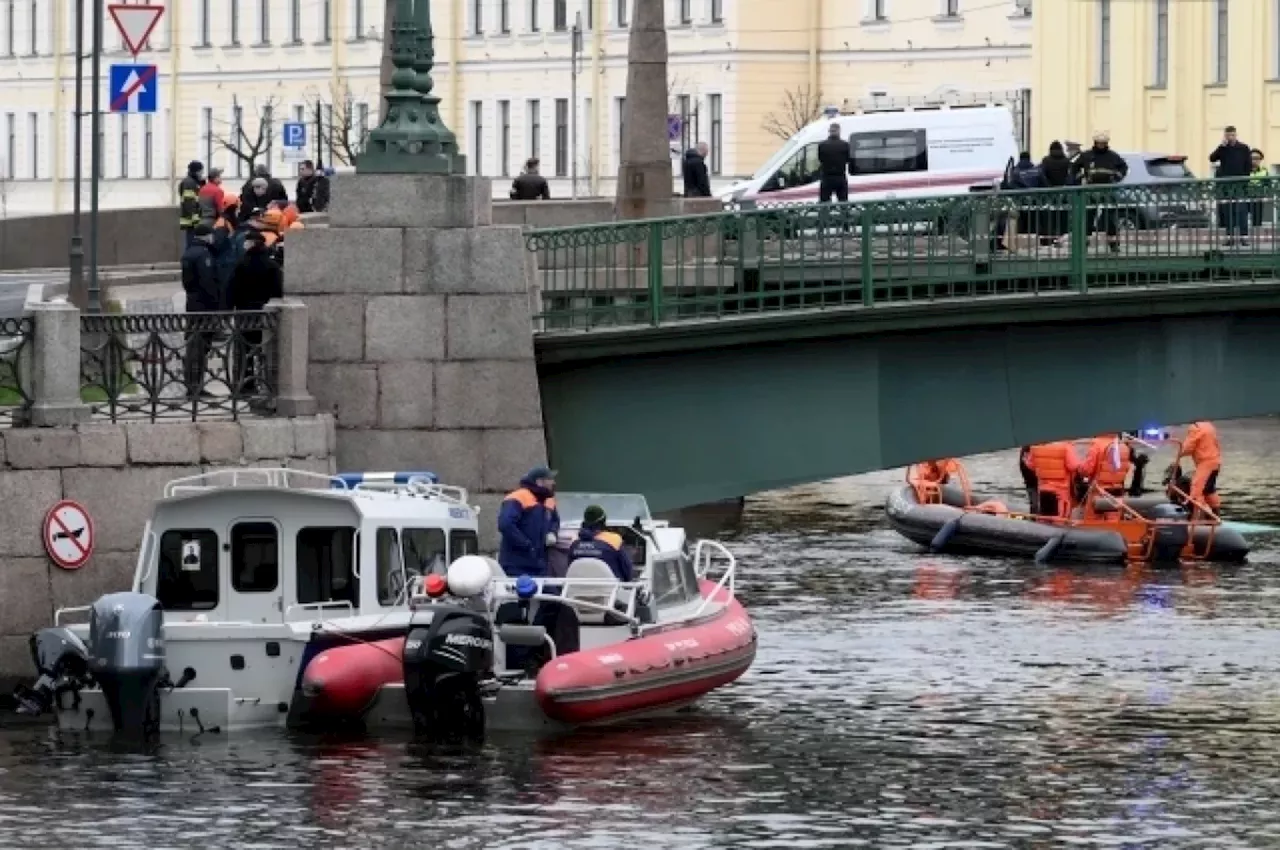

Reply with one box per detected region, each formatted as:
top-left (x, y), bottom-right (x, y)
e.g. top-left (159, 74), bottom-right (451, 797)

top-left (356, 0), bottom-right (466, 174)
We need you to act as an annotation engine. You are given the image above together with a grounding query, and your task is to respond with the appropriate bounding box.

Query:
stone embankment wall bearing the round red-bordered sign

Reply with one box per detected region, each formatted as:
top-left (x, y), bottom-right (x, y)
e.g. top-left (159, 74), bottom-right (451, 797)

top-left (0, 415), bottom-right (335, 695)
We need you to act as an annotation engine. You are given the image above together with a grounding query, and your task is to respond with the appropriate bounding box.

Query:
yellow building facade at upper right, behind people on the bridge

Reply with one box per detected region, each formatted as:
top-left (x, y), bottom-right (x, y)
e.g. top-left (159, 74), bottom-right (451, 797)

top-left (1033, 0), bottom-right (1280, 177)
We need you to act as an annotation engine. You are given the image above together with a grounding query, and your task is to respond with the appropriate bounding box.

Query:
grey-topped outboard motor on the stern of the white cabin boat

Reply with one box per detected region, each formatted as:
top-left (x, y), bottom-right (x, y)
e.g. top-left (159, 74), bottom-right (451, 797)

top-left (88, 593), bottom-right (168, 735)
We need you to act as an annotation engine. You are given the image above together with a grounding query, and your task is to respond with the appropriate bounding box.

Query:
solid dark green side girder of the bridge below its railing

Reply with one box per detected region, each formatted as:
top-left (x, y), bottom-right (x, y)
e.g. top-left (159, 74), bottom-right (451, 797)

top-left (539, 293), bottom-right (1280, 509)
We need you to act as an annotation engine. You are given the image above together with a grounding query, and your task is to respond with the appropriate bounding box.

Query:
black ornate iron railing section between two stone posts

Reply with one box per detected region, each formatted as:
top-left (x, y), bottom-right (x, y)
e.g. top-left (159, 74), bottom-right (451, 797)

top-left (81, 311), bottom-right (278, 422)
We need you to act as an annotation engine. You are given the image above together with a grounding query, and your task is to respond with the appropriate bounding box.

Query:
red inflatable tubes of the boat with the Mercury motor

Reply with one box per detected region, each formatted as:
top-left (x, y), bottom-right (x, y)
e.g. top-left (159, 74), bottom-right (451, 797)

top-left (301, 580), bottom-right (756, 726)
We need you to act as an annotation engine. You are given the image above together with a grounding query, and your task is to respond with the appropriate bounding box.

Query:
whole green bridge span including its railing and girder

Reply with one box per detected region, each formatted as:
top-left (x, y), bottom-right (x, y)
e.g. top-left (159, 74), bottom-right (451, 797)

top-left (527, 179), bottom-right (1280, 509)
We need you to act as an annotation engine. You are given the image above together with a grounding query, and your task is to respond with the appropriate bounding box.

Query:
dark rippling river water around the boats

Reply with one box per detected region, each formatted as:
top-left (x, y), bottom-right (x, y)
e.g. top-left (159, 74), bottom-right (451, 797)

top-left (0, 420), bottom-right (1280, 850)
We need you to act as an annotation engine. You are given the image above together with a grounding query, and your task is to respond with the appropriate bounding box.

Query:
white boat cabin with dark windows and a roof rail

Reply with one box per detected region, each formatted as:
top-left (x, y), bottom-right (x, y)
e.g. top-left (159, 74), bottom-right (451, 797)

top-left (133, 469), bottom-right (479, 623)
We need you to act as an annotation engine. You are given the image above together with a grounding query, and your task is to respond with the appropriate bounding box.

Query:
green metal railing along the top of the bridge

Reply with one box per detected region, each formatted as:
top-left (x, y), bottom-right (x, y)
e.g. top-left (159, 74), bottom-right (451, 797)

top-left (529, 178), bottom-right (1280, 332)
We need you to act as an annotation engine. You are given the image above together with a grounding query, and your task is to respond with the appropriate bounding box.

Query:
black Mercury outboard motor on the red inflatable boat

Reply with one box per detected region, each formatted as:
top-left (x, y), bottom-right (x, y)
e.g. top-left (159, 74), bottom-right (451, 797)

top-left (403, 604), bottom-right (493, 737)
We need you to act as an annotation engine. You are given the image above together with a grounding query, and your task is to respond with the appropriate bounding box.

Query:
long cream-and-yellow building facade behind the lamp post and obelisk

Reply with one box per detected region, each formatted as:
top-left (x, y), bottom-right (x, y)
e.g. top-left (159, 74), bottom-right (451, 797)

top-left (0, 0), bottom-right (1039, 215)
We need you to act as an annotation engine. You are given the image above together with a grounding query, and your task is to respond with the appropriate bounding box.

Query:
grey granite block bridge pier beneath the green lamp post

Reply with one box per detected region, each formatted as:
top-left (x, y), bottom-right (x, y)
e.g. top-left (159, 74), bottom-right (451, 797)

top-left (285, 174), bottom-right (547, 548)
